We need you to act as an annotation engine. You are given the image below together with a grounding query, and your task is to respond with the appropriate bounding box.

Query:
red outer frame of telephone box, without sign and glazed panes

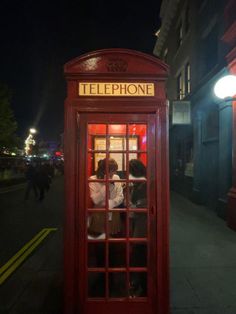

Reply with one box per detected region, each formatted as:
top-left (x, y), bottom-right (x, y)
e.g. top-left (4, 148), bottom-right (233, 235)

top-left (64, 49), bottom-right (169, 314)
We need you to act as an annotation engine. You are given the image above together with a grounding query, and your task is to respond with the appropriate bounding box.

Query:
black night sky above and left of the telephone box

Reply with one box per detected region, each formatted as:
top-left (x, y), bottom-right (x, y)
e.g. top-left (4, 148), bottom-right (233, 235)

top-left (0, 0), bottom-right (161, 141)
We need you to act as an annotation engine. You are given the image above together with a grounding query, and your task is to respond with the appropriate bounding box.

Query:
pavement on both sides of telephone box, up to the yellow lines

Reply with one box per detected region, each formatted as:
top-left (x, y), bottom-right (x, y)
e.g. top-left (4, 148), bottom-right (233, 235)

top-left (0, 193), bottom-right (236, 314)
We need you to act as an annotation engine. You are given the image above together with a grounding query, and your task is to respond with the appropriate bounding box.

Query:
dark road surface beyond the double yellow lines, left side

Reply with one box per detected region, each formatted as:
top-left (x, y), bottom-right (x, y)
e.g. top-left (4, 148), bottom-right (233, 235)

top-left (0, 177), bottom-right (63, 265)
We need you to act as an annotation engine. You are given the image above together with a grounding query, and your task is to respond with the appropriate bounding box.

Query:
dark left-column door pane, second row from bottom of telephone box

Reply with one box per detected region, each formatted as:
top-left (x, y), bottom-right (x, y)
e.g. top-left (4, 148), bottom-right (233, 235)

top-left (88, 242), bottom-right (106, 267)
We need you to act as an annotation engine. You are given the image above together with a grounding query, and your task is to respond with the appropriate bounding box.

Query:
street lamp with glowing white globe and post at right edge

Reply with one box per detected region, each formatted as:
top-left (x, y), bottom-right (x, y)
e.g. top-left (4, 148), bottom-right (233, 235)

top-left (214, 75), bottom-right (236, 231)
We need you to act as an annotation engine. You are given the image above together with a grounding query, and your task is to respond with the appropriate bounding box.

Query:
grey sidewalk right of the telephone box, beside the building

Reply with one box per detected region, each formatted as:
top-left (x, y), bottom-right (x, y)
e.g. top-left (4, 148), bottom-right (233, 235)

top-left (170, 193), bottom-right (236, 314)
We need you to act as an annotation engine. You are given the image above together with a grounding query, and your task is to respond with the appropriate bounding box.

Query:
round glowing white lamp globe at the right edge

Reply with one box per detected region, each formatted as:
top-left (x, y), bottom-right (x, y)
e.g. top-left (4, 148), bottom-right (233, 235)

top-left (214, 75), bottom-right (236, 99)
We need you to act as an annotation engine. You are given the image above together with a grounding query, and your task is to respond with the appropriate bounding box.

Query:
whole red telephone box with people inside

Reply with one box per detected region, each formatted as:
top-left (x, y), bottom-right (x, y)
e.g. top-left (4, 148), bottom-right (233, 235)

top-left (64, 49), bottom-right (169, 314)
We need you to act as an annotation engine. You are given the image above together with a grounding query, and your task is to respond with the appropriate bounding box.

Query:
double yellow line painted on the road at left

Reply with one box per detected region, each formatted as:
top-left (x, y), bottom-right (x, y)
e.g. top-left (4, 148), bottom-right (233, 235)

top-left (0, 228), bottom-right (57, 285)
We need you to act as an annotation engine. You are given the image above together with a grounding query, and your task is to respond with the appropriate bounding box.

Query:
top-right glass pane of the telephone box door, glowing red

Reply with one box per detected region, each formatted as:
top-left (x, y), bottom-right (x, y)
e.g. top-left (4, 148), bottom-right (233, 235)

top-left (129, 124), bottom-right (147, 151)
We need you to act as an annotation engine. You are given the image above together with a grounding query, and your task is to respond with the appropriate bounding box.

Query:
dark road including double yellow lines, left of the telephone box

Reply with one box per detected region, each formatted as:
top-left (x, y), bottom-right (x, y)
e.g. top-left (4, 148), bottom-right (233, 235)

top-left (0, 177), bottom-right (64, 314)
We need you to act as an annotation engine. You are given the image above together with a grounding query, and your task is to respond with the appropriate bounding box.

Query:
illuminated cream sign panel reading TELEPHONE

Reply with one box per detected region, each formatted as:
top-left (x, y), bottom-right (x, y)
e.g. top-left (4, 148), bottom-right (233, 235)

top-left (79, 82), bottom-right (155, 97)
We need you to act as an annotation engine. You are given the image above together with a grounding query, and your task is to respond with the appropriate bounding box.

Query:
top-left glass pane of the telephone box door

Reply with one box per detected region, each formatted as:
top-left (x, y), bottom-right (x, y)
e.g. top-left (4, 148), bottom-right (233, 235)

top-left (87, 124), bottom-right (106, 150)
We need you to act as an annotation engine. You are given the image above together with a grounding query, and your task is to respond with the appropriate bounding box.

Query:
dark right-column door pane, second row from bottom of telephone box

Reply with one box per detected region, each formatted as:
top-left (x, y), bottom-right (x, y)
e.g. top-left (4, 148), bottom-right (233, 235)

top-left (130, 243), bottom-right (147, 267)
